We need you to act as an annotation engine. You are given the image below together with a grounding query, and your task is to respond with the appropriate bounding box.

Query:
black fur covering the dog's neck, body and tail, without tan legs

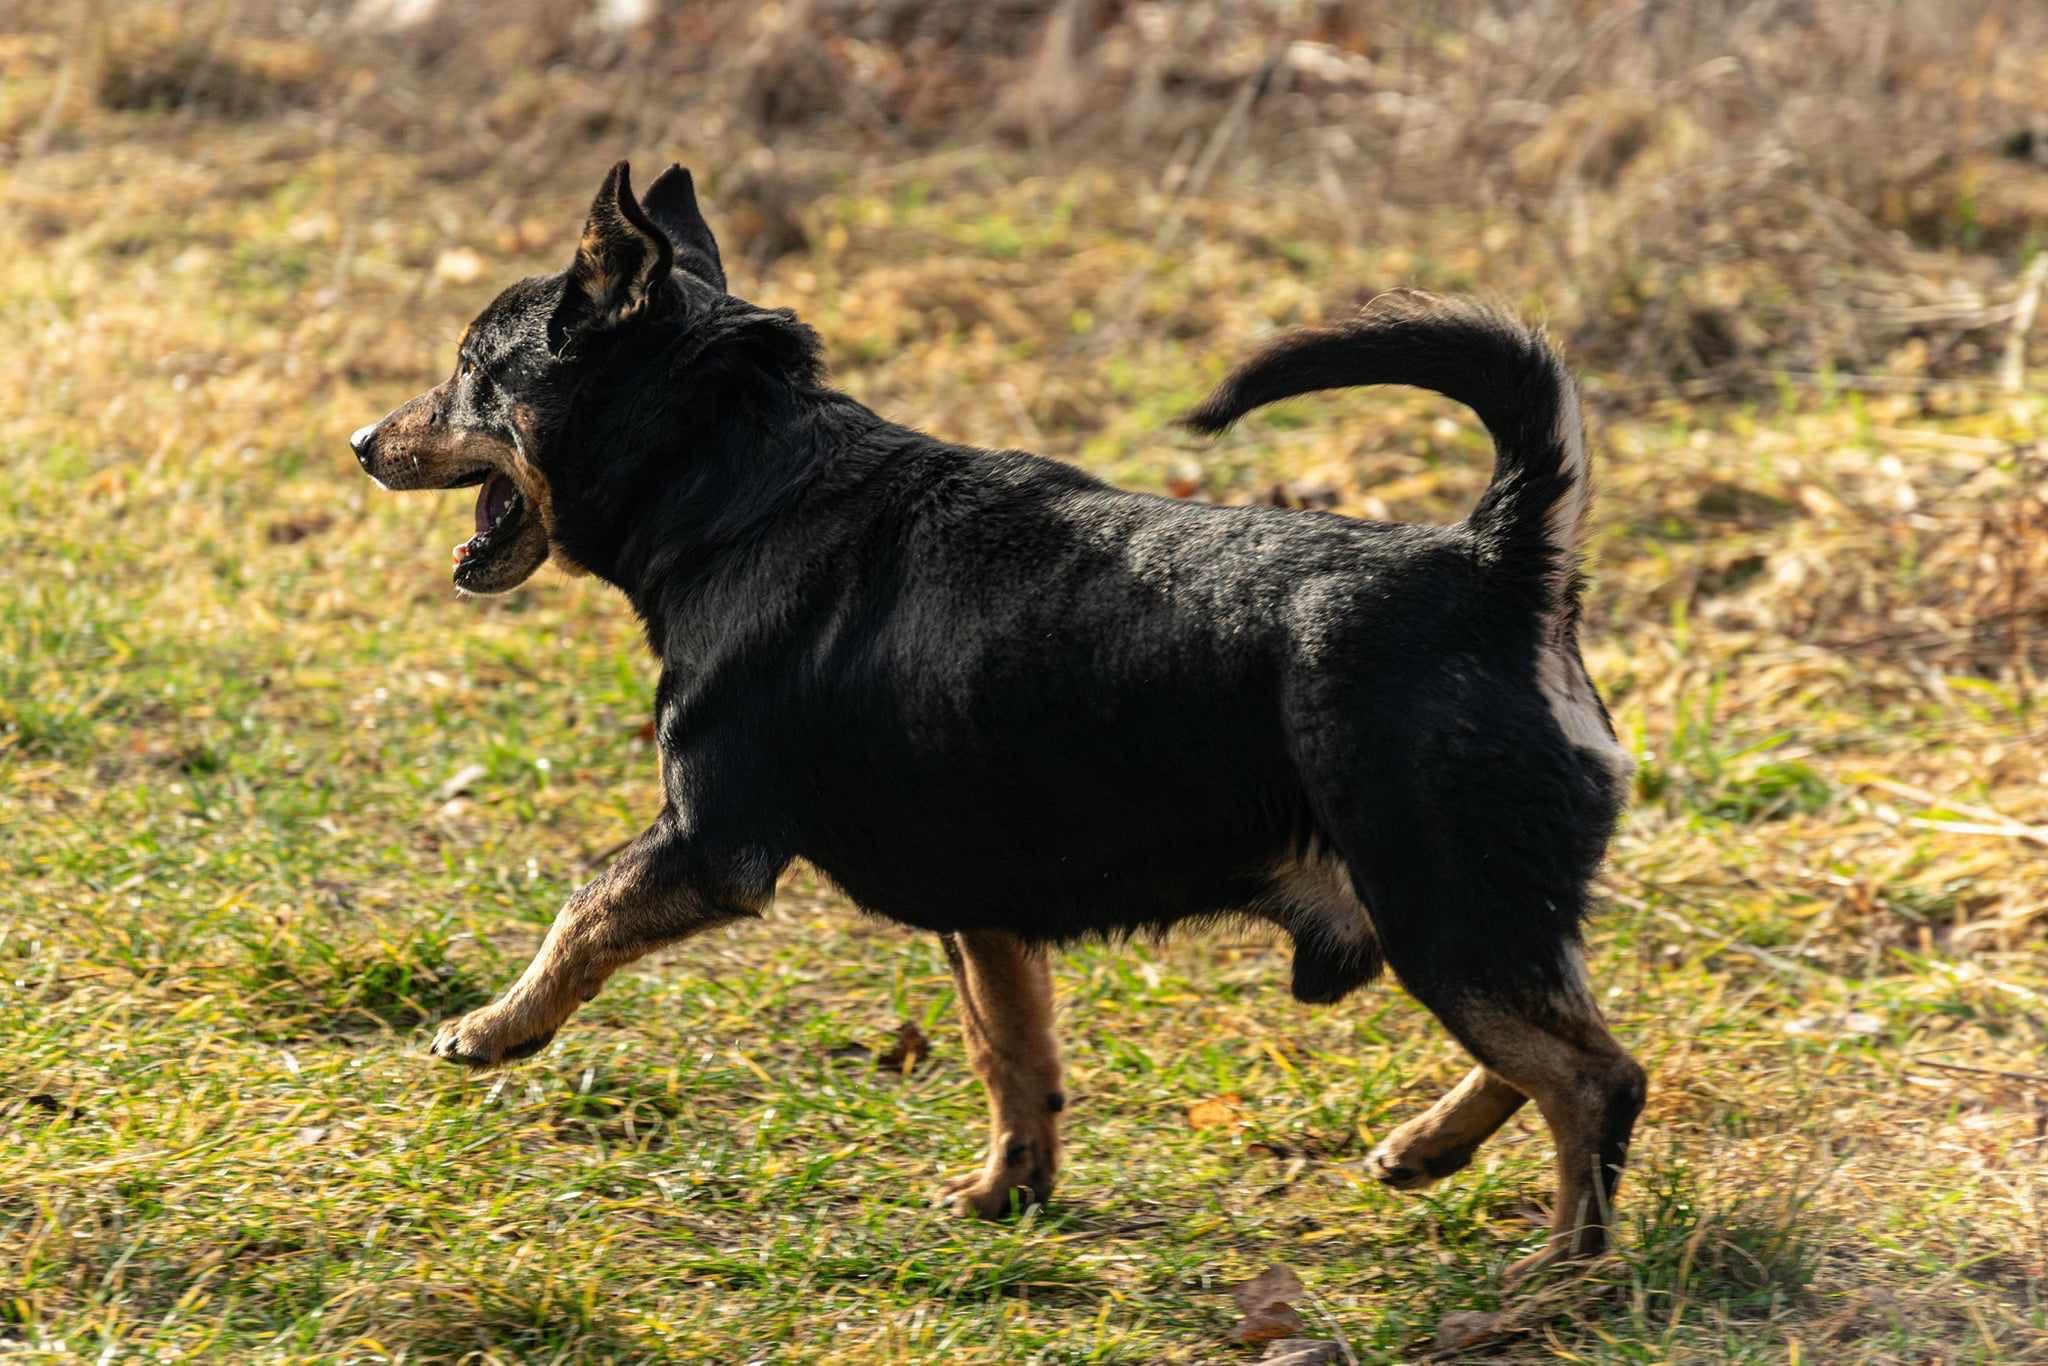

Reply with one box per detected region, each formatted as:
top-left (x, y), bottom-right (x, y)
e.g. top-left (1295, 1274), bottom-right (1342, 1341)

top-left (419, 162), bottom-right (1620, 1015)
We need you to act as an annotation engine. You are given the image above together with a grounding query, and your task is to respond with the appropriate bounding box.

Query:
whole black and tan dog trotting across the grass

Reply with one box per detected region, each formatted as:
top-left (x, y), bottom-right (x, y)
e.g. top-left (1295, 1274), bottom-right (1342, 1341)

top-left (350, 162), bottom-right (1647, 1274)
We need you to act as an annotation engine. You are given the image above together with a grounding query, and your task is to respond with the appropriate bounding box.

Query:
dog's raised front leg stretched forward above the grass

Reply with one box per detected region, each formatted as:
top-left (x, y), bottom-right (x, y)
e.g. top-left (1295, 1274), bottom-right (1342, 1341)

top-left (432, 809), bottom-right (776, 1067)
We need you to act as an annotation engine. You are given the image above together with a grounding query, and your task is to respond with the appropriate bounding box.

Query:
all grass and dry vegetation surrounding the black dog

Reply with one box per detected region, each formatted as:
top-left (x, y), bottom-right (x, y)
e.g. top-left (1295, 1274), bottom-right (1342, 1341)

top-left (0, 0), bottom-right (2048, 1362)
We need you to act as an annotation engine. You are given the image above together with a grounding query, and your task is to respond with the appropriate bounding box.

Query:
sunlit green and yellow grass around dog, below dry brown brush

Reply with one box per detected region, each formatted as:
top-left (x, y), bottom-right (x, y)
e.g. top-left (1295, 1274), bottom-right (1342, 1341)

top-left (0, 15), bottom-right (2048, 1362)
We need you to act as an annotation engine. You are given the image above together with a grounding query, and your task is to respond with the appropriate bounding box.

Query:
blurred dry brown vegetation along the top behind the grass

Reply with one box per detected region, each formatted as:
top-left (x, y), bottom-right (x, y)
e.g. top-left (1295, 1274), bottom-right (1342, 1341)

top-left (16, 0), bottom-right (2048, 378)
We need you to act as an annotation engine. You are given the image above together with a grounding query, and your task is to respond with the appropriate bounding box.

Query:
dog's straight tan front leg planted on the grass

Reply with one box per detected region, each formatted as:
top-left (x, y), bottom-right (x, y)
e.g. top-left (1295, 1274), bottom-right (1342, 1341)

top-left (940, 930), bottom-right (1067, 1219)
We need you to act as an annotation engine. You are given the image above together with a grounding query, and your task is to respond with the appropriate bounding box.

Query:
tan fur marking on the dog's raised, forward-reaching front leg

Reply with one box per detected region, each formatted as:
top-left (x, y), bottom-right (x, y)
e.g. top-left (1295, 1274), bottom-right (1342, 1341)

top-left (432, 823), bottom-right (766, 1067)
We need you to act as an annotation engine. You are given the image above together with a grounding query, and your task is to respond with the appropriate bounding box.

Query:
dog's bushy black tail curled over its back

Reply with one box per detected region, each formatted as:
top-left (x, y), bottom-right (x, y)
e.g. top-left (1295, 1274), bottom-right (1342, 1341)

top-left (1182, 289), bottom-right (1593, 608)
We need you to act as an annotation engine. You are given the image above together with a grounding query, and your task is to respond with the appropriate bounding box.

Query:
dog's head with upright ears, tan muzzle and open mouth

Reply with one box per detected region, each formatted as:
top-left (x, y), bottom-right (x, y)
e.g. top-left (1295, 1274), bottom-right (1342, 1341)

top-left (348, 162), bottom-right (725, 594)
